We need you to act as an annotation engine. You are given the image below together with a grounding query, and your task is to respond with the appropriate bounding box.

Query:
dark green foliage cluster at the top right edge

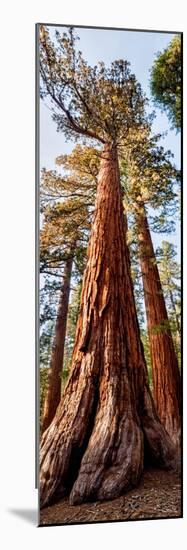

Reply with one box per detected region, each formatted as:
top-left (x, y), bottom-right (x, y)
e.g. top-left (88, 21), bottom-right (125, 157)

top-left (151, 36), bottom-right (181, 130)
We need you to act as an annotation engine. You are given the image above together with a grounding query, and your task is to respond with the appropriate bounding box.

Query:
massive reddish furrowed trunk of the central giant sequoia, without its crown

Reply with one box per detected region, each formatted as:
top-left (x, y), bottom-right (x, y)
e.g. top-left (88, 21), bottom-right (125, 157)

top-left (40, 146), bottom-right (173, 506)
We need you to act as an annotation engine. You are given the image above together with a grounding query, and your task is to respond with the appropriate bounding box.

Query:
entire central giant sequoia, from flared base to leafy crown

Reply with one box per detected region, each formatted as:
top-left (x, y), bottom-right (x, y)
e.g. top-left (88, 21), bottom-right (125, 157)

top-left (40, 27), bottom-right (173, 506)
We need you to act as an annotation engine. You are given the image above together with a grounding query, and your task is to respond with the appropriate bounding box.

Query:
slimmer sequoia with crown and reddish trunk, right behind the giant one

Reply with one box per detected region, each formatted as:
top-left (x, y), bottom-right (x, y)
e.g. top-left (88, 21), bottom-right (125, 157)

top-left (122, 132), bottom-right (181, 444)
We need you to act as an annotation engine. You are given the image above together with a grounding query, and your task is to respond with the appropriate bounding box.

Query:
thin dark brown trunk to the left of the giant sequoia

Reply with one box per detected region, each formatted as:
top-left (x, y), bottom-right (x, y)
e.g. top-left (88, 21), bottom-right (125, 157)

top-left (42, 254), bottom-right (73, 432)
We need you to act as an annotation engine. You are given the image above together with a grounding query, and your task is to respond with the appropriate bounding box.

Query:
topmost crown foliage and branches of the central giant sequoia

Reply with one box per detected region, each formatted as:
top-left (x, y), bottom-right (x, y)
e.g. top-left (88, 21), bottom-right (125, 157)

top-left (40, 25), bottom-right (148, 144)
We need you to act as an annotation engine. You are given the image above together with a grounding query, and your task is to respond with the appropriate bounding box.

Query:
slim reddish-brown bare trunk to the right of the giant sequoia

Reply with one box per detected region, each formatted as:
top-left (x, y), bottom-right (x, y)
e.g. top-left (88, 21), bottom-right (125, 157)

top-left (136, 205), bottom-right (181, 444)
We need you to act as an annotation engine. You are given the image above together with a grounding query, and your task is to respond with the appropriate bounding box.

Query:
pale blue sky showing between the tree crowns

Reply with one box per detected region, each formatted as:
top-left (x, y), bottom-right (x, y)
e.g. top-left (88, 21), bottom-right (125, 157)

top-left (40, 27), bottom-right (181, 264)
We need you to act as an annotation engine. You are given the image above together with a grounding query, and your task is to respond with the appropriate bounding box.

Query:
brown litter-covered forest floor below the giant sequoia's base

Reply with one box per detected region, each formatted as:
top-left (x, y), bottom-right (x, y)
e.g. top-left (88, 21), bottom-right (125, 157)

top-left (40, 469), bottom-right (182, 525)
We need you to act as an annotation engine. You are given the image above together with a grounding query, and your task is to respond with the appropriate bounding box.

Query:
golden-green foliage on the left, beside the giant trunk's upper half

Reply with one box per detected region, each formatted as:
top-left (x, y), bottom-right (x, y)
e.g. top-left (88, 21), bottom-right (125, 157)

top-left (40, 145), bottom-right (100, 338)
